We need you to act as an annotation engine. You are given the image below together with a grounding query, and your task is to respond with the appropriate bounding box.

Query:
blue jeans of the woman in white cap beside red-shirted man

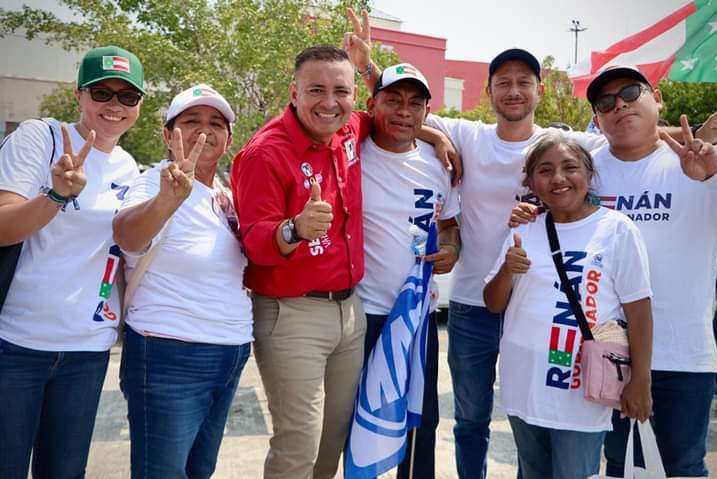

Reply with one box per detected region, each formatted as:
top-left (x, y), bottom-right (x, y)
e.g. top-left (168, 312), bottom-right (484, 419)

top-left (122, 327), bottom-right (251, 479)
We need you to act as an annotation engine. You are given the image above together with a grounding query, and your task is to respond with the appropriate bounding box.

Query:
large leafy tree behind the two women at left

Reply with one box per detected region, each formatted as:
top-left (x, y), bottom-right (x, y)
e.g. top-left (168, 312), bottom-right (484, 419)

top-left (0, 0), bottom-right (397, 163)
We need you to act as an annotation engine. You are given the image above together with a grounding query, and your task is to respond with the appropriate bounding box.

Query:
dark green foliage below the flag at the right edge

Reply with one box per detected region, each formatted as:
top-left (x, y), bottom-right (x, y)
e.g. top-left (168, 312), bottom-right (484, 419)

top-left (658, 80), bottom-right (717, 126)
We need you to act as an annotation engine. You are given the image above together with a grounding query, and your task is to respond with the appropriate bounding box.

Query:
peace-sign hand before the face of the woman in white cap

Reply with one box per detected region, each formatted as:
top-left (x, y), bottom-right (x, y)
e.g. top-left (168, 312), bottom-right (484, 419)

top-left (159, 128), bottom-right (207, 205)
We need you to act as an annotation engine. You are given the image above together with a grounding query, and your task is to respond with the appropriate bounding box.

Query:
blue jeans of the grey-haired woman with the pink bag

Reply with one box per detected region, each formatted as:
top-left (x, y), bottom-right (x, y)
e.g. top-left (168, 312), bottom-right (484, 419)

top-left (508, 416), bottom-right (604, 479)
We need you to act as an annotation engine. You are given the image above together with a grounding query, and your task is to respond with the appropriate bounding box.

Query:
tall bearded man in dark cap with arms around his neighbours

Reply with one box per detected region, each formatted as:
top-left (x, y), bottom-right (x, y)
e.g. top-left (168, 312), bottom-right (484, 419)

top-left (427, 48), bottom-right (604, 479)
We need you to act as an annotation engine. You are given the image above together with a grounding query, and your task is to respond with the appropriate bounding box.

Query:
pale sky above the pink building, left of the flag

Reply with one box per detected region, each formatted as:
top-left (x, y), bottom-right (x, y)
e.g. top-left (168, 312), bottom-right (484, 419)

top-left (373, 0), bottom-right (689, 68)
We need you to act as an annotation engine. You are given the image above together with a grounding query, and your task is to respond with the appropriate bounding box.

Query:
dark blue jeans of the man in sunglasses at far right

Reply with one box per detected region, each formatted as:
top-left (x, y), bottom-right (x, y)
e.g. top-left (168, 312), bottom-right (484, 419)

top-left (605, 371), bottom-right (715, 477)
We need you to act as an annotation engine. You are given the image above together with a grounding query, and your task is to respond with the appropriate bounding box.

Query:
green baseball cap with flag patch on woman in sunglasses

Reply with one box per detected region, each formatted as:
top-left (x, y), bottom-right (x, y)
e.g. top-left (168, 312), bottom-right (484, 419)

top-left (77, 45), bottom-right (145, 93)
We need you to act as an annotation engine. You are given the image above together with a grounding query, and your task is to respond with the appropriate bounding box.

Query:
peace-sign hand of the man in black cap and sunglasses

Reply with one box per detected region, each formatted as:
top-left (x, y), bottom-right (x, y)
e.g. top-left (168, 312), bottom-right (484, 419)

top-left (660, 115), bottom-right (717, 181)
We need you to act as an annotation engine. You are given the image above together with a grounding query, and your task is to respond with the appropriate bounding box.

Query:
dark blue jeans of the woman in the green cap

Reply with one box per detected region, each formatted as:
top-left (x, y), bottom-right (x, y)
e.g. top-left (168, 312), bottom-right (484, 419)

top-left (0, 339), bottom-right (110, 479)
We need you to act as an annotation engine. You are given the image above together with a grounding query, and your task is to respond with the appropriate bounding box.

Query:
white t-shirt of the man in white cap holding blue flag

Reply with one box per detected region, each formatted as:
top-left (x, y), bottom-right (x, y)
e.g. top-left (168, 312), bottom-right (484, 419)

top-left (358, 137), bottom-right (458, 314)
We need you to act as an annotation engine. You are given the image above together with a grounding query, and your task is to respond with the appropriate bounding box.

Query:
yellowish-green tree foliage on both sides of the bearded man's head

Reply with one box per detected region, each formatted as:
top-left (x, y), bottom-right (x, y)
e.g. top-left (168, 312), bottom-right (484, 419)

top-left (438, 56), bottom-right (592, 130)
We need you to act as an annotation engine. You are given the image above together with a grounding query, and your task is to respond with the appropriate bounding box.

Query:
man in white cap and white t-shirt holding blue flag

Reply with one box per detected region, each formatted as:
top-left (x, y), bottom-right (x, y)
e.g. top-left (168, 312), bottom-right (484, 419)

top-left (358, 63), bottom-right (460, 479)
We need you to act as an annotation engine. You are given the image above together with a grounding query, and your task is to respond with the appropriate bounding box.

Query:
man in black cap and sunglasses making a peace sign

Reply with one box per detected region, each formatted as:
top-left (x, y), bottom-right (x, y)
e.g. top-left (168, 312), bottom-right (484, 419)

top-left (587, 66), bottom-right (717, 477)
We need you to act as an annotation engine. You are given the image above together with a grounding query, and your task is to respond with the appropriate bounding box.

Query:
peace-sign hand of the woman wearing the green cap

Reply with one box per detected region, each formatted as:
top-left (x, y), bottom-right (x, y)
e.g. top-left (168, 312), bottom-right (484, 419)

top-left (51, 125), bottom-right (96, 198)
